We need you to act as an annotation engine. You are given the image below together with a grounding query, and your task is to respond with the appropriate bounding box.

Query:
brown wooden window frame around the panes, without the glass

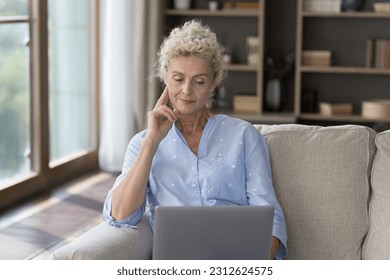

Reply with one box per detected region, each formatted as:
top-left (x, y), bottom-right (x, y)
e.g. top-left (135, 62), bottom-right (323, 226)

top-left (0, 0), bottom-right (99, 209)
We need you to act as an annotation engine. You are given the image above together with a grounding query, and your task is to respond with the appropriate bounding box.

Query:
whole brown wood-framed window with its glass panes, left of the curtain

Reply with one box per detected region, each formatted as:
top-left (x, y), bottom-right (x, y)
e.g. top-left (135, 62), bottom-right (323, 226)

top-left (0, 0), bottom-right (98, 208)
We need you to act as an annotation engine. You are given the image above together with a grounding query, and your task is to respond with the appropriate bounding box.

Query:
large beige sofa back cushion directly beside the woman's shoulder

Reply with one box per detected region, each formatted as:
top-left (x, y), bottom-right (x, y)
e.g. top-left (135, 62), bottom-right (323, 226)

top-left (256, 124), bottom-right (376, 259)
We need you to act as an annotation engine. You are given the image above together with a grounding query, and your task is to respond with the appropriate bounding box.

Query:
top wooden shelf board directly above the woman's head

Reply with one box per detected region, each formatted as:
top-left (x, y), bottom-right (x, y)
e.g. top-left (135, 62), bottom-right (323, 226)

top-left (165, 9), bottom-right (259, 17)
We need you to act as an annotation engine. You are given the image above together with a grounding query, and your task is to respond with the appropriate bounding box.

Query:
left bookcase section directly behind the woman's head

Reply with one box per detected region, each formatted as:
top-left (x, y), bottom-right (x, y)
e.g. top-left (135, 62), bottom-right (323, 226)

top-left (163, 0), bottom-right (295, 123)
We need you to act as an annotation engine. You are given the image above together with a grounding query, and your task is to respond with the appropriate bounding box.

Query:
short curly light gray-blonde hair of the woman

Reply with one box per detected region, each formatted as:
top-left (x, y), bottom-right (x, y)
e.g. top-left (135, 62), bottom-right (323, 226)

top-left (156, 20), bottom-right (225, 89)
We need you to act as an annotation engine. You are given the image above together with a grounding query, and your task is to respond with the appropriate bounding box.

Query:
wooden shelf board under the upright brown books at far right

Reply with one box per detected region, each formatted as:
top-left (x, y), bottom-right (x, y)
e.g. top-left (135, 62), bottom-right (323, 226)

top-left (300, 66), bottom-right (390, 75)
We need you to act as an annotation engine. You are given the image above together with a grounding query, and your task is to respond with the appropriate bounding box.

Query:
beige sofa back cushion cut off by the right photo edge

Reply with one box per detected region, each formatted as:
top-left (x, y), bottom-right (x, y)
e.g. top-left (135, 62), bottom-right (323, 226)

top-left (363, 130), bottom-right (390, 259)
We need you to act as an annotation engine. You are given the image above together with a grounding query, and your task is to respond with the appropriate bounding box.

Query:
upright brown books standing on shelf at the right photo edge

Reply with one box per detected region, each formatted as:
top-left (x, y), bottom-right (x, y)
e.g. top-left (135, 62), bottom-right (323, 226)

top-left (366, 39), bottom-right (390, 69)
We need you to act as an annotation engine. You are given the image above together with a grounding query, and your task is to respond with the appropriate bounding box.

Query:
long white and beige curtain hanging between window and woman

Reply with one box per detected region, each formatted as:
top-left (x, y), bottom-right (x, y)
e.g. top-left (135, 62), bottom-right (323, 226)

top-left (99, 0), bottom-right (161, 172)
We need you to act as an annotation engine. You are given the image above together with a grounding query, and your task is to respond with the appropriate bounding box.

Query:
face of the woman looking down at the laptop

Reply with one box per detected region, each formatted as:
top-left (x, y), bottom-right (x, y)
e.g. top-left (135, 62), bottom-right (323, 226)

top-left (166, 56), bottom-right (215, 115)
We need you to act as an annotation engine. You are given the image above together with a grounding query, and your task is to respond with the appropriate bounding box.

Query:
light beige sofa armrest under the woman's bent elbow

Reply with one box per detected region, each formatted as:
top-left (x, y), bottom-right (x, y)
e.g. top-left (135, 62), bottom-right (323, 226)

top-left (51, 214), bottom-right (153, 260)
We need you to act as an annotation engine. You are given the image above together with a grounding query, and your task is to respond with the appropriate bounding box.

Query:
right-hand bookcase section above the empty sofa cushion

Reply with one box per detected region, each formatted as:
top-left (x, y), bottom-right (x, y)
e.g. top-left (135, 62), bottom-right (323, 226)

top-left (294, 0), bottom-right (390, 124)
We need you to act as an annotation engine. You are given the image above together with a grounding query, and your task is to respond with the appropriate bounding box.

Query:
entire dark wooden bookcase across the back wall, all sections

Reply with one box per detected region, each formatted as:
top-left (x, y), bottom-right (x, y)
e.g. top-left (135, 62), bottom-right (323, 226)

top-left (162, 0), bottom-right (390, 124)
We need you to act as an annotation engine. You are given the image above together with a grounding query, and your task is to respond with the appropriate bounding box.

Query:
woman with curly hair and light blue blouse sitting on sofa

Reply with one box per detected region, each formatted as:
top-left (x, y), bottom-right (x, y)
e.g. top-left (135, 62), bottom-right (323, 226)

top-left (103, 21), bottom-right (287, 258)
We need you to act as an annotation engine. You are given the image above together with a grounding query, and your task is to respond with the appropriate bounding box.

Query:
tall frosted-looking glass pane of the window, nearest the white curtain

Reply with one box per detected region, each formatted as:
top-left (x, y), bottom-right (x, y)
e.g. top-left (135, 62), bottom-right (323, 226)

top-left (48, 0), bottom-right (93, 163)
